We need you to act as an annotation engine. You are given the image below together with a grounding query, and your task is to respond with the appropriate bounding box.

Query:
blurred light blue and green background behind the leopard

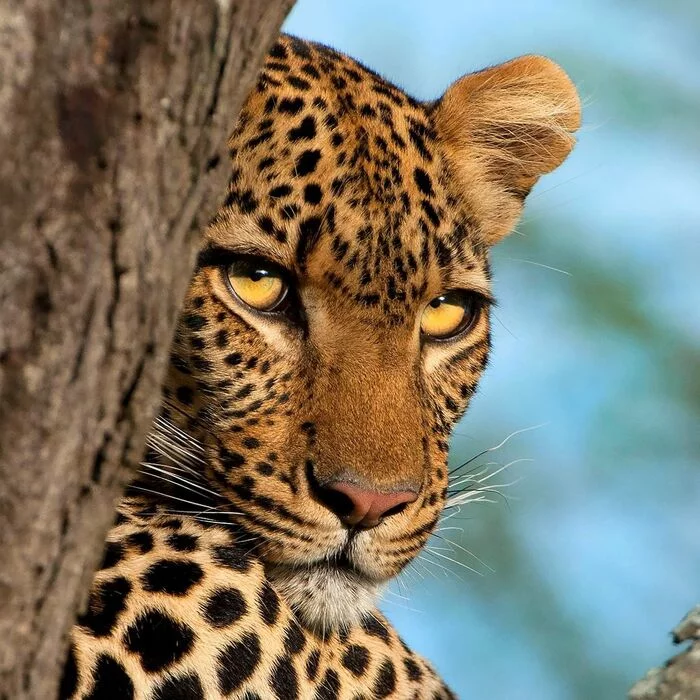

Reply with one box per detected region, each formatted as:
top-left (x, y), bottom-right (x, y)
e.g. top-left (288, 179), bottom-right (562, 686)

top-left (285, 0), bottom-right (700, 700)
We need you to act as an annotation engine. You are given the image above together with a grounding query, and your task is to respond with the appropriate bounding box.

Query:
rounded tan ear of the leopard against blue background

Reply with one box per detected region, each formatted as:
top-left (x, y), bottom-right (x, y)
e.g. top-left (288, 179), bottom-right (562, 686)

top-left (433, 56), bottom-right (581, 245)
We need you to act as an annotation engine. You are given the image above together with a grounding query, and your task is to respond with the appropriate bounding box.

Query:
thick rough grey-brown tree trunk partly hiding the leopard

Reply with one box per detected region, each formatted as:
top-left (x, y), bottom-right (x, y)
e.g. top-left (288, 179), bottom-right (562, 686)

top-left (0, 0), bottom-right (293, 700)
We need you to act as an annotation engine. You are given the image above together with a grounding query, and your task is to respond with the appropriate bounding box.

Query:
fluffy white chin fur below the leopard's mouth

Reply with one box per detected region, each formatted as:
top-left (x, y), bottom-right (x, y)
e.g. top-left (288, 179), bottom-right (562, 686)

top-left (268, 565), bottom-right (379, 634)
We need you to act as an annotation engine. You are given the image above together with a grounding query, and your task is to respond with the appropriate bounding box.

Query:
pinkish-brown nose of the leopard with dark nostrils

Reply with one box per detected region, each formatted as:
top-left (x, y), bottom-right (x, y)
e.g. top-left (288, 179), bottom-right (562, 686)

top-left (322, 481), bottom-right (418, 528)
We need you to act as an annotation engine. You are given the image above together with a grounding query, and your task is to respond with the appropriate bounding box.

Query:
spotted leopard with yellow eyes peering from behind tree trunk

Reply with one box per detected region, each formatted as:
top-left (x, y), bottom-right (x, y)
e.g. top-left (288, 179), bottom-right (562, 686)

top-left (60, 34), bottom-right (581, 700)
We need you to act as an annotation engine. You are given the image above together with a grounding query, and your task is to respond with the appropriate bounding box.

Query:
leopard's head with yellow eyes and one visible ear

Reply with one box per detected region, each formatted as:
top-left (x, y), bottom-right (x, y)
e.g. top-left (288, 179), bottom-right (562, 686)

top-left (163, 37), bottom-right (579, 629)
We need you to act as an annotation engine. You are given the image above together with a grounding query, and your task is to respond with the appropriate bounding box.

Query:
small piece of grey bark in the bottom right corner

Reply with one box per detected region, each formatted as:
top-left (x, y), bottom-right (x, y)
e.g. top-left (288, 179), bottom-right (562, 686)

top-left (629, 605), bottom-right (700, 700)
